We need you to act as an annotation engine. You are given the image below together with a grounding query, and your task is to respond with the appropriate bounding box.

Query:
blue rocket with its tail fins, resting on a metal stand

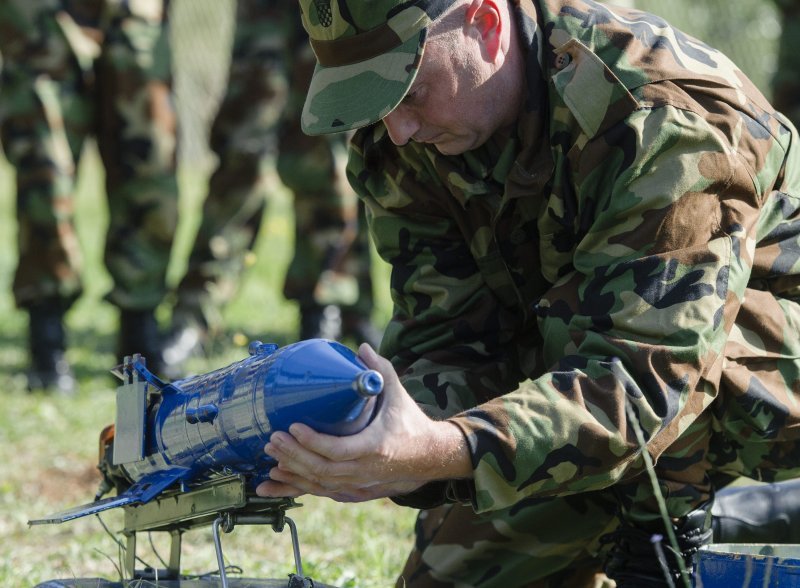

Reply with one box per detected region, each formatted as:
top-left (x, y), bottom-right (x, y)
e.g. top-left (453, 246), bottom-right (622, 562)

top-left (29, 339), bottom-right (383, 524)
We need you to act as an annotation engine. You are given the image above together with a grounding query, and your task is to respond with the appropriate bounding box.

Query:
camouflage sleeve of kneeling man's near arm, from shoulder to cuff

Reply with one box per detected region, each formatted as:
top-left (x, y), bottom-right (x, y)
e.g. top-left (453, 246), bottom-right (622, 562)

top-left (454, 107), bottom-right (768, 511)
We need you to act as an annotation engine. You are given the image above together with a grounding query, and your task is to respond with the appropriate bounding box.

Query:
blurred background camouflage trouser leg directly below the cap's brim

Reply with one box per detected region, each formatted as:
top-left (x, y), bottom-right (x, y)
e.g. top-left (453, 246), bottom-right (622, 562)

top-left (278, 19), bottom-right (373, 319)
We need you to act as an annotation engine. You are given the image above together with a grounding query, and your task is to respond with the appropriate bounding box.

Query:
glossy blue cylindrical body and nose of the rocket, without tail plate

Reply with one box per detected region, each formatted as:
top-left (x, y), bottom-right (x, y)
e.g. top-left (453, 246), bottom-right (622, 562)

top-left (123, 339), bottom-right (383, 482)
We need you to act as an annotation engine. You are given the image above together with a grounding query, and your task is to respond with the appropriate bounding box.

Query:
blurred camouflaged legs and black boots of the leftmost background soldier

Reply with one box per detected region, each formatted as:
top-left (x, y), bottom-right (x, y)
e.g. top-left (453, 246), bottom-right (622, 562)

top-left (0, 0), bottom-right (177, 391)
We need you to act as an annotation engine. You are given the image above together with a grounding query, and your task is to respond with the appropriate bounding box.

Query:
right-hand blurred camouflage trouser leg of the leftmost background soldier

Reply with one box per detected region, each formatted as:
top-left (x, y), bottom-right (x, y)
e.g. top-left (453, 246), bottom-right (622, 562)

top-left (95, 0), bottom-right (178, 310)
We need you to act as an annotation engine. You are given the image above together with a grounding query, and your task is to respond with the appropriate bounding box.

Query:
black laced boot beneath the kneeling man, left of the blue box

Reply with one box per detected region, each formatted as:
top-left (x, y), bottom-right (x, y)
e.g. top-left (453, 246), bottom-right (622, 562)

top-left (603, 502), bottom-right (712, 588)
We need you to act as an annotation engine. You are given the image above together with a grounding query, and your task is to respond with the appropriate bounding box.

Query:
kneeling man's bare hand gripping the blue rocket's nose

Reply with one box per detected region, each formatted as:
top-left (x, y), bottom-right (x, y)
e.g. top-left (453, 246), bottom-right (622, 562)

top-left (256, 344), bottom-right (472, 502)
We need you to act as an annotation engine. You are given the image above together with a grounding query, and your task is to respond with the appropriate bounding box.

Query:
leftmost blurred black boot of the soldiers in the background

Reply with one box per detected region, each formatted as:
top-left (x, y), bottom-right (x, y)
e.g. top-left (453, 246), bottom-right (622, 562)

top-left (28, 300), bottom-right (75, 394)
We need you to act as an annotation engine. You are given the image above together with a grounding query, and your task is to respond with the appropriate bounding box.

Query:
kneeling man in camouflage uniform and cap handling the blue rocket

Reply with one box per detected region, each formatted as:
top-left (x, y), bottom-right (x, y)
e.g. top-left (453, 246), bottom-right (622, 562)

top-left (258, 0), bottom-right (800, 588)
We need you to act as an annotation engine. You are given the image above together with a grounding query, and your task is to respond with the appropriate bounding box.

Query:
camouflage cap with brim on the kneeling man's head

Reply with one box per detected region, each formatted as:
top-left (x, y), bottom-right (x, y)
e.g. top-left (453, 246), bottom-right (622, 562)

top-left (300, 0), bottom-right (455, 135)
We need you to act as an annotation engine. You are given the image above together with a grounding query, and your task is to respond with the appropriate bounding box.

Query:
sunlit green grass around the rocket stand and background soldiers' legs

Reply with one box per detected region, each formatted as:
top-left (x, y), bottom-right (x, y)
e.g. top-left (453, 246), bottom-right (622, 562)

top-left (0, 144), bottom-right (414, 587)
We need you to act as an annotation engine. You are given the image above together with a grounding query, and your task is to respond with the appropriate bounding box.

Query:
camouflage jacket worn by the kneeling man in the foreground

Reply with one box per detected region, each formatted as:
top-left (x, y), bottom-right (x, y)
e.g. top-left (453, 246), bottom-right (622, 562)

top-left (349, 0), bottom-right (800, 512)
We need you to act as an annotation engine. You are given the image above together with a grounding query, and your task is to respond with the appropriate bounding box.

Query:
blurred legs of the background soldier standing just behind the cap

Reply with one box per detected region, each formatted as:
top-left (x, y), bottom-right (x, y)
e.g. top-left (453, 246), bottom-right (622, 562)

top-left (164, 0), bottom-right (380, 364)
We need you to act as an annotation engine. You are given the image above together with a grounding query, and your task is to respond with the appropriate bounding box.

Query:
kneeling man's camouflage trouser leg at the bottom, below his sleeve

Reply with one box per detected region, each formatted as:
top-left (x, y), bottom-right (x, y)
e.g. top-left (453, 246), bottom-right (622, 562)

top-left (396, 493), bottom-right (617, 588)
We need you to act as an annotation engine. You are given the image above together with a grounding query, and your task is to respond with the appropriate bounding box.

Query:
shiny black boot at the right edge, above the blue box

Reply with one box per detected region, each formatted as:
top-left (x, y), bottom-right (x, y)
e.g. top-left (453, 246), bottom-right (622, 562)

top-left (711, 480), bottom-right (800, 543)
